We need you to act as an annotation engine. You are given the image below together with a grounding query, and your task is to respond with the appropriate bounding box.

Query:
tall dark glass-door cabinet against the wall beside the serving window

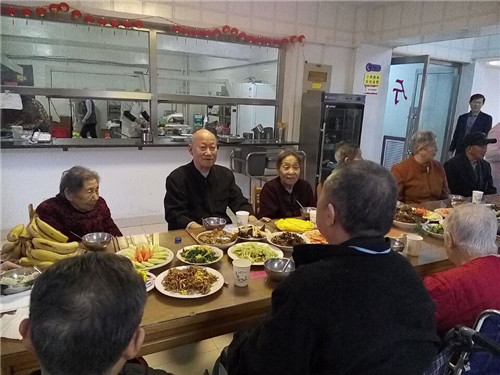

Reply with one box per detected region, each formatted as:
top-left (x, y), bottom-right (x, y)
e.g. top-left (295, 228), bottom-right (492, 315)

top-left (299, 91), bottom-right (365, 187)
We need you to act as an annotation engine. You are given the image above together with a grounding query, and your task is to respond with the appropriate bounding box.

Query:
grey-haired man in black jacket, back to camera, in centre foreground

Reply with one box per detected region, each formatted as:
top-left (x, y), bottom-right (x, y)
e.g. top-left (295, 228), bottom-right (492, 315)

top-left (221, 161), bottom-right (439, 375)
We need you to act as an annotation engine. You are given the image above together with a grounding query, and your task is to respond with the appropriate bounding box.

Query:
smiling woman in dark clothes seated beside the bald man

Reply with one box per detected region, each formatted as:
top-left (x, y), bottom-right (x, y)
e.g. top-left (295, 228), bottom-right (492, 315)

top-left (257, 150), bottom-right (316, 219)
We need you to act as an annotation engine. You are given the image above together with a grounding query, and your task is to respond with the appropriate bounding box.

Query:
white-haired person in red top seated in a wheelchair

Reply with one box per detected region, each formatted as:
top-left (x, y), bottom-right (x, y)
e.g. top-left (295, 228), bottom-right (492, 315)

top-left (424, 204), bottom-right (500, 333)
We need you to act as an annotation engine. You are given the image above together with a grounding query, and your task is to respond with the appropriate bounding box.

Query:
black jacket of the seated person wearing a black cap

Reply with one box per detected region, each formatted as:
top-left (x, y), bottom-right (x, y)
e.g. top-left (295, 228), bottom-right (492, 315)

top-left (444, 153), bottom-right (497, 197)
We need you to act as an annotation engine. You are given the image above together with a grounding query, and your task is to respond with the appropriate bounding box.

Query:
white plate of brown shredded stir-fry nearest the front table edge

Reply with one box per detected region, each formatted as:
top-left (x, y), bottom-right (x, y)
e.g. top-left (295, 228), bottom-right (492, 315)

top-left (155, 266), bottom-right (224, 298)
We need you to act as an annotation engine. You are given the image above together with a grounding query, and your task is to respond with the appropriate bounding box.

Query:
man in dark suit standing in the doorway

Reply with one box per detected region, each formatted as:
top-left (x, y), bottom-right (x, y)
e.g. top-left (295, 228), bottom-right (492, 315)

top-left (449, 94), bottom-right (493, 157)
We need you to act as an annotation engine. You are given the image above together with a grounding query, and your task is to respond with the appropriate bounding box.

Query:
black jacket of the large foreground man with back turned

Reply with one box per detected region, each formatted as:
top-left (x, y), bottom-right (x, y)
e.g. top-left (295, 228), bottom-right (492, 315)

top-left (227, 237), bottom-right (439, 375)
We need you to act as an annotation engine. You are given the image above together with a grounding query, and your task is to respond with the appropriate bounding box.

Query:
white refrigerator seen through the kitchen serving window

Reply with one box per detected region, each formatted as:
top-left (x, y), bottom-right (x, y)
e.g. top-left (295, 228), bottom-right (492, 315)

top-left (229, 83), bottom-right (276, 136)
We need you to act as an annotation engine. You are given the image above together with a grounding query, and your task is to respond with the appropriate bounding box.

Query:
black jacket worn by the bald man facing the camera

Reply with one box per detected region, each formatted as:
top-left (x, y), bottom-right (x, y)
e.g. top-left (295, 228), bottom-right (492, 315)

top-left (163, 162), bottom-right (253, 230)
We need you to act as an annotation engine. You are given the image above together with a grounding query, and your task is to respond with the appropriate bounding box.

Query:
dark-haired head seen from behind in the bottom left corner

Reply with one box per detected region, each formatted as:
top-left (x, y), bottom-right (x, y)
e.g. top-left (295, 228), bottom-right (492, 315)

top-left (19, 251), bottom-right (171, 375)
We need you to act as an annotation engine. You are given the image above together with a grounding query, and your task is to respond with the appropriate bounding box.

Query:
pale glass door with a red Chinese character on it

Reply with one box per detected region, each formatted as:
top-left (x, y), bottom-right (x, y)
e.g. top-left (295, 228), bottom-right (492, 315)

top-left (382, 56), bottom-right (429, 162)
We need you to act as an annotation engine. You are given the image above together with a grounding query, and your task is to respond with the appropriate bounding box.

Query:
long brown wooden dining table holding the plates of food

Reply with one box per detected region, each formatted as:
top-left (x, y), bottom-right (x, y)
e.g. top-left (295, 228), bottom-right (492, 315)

top-left (1, 212), bottom-right (464, 375)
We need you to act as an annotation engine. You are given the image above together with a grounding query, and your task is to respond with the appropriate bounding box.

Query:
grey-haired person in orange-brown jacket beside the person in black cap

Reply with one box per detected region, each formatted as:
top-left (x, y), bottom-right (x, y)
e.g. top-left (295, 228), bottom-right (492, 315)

top-left (391, 131), bottom-right (450, 203)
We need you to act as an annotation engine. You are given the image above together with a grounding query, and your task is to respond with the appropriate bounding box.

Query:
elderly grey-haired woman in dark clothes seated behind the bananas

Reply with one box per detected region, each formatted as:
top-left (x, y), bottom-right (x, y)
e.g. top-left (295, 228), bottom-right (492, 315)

top-left (36, 166), bottom-right (122, 241)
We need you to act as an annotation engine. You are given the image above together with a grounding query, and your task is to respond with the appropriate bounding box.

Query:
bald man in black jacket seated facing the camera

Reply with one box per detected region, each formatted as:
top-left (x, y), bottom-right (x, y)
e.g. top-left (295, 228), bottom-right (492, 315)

top-left (163, 129), bottom-right (256, 230)
